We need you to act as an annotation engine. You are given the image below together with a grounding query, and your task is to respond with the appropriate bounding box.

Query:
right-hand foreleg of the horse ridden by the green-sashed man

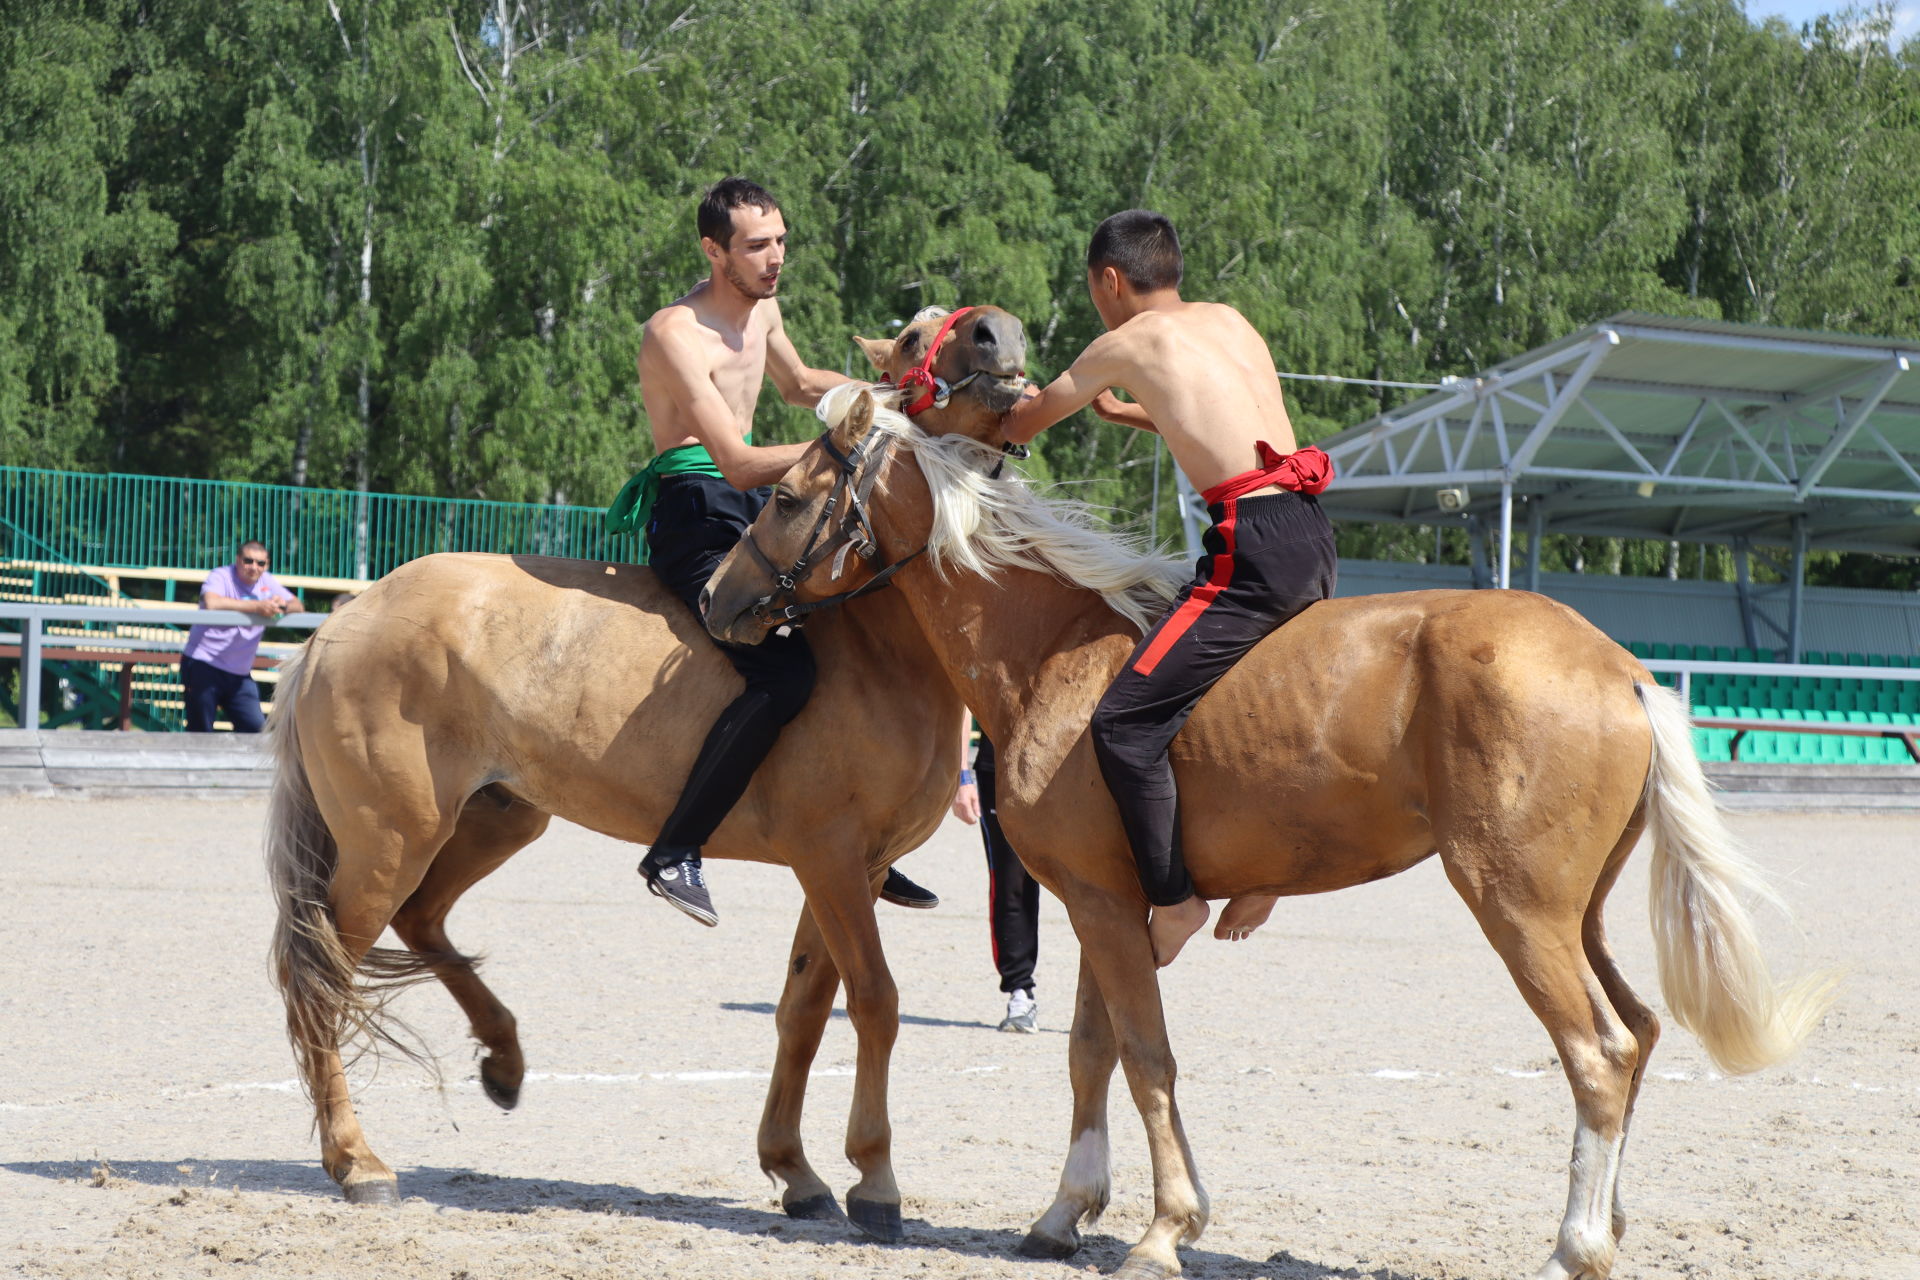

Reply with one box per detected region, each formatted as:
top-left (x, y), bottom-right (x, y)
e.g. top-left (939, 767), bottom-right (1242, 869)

top-left (793, 842), bottom-right (906, 1244)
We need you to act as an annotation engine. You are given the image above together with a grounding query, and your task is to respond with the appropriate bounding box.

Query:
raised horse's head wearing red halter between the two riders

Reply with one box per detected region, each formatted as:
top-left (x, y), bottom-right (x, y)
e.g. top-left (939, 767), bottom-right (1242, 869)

top-left (854, 307), bottom-right (1027, 445)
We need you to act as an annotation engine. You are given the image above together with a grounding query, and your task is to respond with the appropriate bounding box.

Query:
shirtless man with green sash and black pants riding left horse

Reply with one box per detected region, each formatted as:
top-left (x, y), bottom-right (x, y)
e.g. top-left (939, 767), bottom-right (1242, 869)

top-left (607, 178), bottom-right (939, 925)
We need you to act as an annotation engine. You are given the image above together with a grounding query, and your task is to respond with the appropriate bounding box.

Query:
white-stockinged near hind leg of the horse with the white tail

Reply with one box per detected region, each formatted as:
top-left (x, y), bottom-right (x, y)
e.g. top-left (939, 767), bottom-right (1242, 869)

top-left (1440, 844), bottom-right (1640, 1280)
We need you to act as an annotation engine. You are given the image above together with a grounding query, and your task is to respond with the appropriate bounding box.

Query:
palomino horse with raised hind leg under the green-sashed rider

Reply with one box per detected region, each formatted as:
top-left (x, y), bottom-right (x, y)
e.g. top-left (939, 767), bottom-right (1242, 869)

top-left (267, 309), bottom-right (1025, 1240)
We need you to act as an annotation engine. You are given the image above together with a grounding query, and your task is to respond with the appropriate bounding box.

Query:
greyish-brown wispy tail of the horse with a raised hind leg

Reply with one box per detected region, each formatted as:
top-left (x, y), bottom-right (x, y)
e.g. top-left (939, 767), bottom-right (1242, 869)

top-left (267, 641), bottom-right (441, 1088)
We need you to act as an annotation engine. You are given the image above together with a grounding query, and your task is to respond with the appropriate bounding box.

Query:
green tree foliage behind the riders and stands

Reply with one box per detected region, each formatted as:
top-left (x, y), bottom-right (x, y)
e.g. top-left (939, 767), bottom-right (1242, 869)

top-left (0, 0), bottom-right (1920, 578)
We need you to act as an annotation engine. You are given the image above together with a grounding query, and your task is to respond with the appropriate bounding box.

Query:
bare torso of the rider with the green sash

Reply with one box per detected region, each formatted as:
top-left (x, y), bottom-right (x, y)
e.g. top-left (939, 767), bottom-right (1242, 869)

top-left (639, 280), bottom-right (780, 453)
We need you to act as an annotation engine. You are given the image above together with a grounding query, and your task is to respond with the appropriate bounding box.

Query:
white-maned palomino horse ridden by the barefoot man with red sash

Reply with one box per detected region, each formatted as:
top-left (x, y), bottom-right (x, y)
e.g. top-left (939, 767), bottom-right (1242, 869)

top-left (707, 360), bottom-right (1826, 1280)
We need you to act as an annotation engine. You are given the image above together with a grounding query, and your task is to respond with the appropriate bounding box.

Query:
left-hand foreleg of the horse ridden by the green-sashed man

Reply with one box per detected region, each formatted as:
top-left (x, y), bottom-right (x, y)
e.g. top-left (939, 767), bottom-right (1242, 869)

top-left (760, 906), bottom-right (841, 1219)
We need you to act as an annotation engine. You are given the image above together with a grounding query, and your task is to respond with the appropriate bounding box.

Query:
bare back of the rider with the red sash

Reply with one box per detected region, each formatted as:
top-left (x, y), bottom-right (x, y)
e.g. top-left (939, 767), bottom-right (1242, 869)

top-left (1081, 301), bottom-right (1294, 489)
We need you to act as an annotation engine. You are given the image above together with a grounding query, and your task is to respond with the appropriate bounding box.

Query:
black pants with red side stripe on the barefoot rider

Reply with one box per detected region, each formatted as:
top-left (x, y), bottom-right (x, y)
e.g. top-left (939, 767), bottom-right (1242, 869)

top-left (1092, 493), bottom-right (1338, 906)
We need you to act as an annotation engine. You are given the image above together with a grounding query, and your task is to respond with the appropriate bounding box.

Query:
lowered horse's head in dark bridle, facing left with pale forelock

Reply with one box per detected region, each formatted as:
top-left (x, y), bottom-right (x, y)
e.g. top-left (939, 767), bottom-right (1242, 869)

top-left (701, 387), bottom-right (944, 645)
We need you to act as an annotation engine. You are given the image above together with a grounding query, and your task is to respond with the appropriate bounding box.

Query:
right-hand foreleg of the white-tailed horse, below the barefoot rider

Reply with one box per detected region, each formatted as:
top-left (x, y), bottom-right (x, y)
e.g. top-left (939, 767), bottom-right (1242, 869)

top-left (1064, 885), bottom-right (1208, 1280)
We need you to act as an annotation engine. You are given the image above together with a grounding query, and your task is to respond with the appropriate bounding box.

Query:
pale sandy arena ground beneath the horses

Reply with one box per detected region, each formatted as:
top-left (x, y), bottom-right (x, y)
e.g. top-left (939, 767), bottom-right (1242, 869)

top-left (0, 798), bottom-right (1920, 1280)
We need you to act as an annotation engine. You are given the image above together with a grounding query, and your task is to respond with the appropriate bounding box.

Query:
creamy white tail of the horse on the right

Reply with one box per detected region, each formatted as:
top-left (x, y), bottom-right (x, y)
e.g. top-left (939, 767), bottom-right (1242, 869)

top-left (1634, 683), bottom-right (1837, 1075)
